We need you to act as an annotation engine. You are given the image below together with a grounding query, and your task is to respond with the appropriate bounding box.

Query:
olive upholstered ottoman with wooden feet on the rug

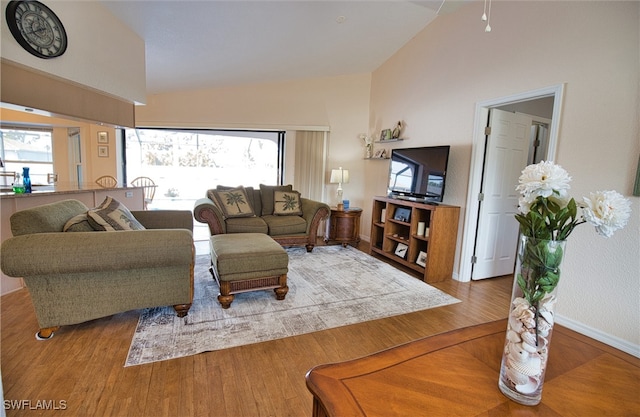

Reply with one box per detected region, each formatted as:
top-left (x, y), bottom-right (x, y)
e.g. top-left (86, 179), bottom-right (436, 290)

top-left (209, 233), bottom-right (289, 308)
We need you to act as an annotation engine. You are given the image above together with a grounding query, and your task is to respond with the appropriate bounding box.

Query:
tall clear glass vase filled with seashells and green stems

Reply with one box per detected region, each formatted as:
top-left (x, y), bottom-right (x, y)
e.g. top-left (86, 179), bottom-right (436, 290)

top-left (498, 235), bottom-right (566, 405)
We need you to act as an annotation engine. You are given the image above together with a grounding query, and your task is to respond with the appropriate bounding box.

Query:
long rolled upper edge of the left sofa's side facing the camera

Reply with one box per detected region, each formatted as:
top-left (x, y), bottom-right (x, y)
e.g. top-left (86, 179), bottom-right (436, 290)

top-left (0, 229), bottom-right (194, 277)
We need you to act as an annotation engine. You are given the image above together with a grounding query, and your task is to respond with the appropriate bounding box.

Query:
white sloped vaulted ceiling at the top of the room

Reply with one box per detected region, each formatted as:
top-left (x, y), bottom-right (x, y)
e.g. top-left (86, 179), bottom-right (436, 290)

top-left (102, 0), bottom-right (470, 94)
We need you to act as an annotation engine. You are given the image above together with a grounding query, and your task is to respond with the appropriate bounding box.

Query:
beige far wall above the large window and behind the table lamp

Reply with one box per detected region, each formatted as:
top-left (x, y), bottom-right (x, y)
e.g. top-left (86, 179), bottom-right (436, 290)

top-left (136, 74), bottom-right (372, 210)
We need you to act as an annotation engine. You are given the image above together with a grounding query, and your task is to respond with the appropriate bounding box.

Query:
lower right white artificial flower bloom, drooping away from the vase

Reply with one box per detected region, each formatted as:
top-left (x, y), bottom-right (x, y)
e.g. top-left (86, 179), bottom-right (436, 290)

top-left (582, 191), bottom-right (631, 237)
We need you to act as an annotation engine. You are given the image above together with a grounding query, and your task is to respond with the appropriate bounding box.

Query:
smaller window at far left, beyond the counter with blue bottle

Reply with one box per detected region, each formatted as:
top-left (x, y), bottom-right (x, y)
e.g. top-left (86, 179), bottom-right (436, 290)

top-left (0, 127), bottom-right (53, 188)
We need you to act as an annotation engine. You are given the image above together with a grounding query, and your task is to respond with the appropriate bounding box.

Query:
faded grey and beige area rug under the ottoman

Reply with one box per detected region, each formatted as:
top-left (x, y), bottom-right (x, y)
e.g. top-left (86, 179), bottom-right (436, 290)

top-left (125, 246), bottom-right (460, 366)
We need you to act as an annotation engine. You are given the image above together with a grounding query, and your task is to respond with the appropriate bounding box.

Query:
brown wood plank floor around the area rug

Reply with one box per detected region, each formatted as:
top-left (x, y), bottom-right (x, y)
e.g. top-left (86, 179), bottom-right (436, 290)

top-left (0, 242), bottom-right (512, 417)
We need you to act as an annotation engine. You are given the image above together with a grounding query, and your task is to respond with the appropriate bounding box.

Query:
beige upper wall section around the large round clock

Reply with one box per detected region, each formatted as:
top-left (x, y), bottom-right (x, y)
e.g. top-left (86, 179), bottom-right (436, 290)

top-left (0, 0), bottom-right (146, 103)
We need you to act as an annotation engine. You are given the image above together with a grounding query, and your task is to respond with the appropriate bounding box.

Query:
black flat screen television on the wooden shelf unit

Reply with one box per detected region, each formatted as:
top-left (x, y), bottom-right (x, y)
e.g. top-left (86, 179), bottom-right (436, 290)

top-left (388, 145), bottom-right (450, 202)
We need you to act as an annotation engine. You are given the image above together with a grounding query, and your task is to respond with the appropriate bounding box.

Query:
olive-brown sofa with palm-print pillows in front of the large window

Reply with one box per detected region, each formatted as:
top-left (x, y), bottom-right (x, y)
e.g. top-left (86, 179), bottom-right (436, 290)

top-left (193, 184), bottom-right (330, 252)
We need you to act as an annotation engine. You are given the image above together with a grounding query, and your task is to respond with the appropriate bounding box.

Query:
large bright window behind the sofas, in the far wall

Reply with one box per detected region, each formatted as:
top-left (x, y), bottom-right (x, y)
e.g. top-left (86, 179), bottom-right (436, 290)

top-left (124, 129), bottom-right (284, 209)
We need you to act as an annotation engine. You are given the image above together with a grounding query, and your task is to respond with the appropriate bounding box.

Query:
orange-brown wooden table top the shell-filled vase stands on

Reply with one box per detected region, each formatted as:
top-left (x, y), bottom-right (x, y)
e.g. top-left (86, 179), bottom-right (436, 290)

top-left (306, 320), bottom-right (640, 417)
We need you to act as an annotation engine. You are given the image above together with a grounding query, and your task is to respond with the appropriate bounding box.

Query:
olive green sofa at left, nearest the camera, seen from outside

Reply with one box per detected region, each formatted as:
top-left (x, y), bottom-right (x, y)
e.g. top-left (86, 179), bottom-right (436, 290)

top-left (0, 200), bottom-right (195, 339)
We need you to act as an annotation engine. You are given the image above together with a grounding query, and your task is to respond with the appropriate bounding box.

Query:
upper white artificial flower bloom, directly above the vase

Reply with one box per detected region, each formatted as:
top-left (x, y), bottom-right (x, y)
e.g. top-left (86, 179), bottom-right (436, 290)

top-left (516, 161), bottom-right (571, 214)
